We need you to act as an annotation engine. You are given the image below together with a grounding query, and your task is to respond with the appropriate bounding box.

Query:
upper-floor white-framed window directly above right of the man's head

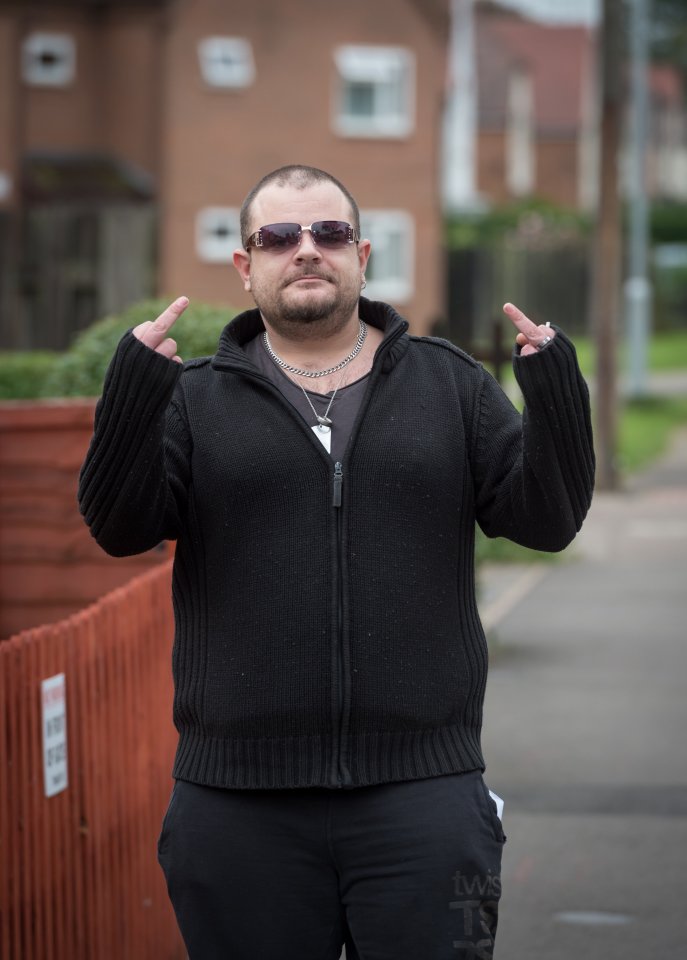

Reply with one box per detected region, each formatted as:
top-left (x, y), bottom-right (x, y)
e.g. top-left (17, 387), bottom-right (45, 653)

top-left (334, 47), bottom-right (415, 137)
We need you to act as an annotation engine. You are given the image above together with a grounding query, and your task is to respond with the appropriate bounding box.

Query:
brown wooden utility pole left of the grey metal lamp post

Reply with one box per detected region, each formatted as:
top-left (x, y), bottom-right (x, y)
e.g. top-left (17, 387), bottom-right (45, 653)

top-left (592, 0), bottom-right (623, 490)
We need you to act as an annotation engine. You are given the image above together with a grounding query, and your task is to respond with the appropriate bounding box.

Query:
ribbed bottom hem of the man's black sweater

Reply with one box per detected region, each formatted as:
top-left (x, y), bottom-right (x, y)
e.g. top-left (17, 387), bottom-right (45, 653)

top-left (173, 727), bottom-right (484, 790)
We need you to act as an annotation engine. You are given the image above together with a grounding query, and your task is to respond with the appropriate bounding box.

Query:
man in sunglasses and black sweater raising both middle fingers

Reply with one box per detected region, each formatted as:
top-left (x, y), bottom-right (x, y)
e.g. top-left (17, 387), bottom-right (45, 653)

top-left (80, 161), bottom-right (594, 960)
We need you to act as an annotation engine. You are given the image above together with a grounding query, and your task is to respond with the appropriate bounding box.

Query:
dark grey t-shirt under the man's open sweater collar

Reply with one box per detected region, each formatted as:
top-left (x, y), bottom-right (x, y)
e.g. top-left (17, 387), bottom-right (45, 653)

top-left (244, 334), bottom-right (369, 462)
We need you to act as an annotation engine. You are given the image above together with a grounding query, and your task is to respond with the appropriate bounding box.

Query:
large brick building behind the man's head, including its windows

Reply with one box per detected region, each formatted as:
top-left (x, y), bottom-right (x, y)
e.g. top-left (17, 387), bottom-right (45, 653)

top-left (0, 0), bottom-right (448, 348)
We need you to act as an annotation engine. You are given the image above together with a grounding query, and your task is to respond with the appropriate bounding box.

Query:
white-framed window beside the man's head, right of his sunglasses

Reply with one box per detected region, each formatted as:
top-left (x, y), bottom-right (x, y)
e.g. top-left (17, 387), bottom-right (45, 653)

top-left (360, 210), bottom-right (415, 303)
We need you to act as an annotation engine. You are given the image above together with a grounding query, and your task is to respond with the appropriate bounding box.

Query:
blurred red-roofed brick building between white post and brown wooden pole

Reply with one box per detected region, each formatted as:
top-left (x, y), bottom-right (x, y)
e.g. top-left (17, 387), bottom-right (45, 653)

top-left (475, 4), bottom-right (598, 209)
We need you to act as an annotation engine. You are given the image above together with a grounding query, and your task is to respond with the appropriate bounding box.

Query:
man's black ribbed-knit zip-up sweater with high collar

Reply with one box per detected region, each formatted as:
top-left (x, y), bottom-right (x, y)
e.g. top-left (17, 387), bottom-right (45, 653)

top-left (79, 299), bottom-right (594, 788)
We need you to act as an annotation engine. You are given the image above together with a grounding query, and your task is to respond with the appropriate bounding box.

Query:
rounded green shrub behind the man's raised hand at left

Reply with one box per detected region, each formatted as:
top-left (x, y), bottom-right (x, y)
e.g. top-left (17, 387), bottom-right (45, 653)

top-left (40, 299), bottom-right (235, 397)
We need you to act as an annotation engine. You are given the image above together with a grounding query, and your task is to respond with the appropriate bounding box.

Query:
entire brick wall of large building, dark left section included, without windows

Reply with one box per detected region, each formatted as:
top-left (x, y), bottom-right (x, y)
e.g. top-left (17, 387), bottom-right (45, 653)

top-left (0, 0), bottom-right (448, 342)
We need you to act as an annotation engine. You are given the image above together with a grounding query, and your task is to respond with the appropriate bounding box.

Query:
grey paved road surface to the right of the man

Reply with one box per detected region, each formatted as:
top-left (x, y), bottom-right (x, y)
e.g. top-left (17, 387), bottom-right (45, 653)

top-left (483, 433), bottom-right (687, 960)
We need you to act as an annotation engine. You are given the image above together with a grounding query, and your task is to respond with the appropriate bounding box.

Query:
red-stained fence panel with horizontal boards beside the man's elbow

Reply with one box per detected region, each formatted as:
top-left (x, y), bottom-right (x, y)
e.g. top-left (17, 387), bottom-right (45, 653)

top-left (0, 400), bottom-right (169, 639)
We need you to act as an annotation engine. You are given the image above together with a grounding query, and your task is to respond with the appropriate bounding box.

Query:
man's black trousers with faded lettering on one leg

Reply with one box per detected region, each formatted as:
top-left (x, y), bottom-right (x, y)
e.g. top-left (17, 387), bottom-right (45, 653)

top-left (158, 771), bottom-right (505, 960)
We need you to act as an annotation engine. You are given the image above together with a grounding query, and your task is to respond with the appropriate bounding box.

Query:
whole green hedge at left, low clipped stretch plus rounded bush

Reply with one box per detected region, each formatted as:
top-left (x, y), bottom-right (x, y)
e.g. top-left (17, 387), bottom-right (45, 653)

top-left (0, 299), bottom-right (236, 399)
